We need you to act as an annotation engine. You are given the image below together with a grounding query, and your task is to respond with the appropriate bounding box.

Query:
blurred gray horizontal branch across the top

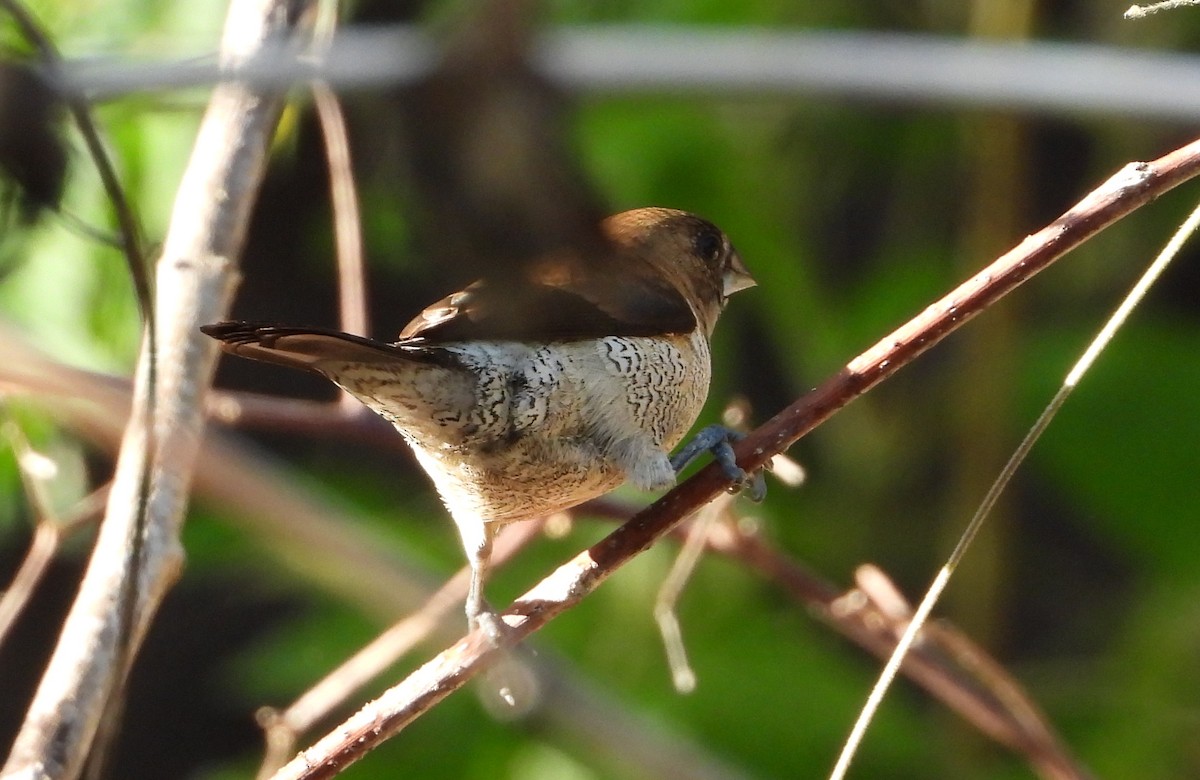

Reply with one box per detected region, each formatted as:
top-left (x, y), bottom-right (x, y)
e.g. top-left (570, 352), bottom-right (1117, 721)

top-left (67, 25), bottom-right (1200, 120)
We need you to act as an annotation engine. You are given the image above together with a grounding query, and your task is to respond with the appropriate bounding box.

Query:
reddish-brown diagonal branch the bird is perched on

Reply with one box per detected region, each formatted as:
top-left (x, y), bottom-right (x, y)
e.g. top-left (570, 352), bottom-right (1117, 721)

top-left (265, 136), bottom-right (1200, 780)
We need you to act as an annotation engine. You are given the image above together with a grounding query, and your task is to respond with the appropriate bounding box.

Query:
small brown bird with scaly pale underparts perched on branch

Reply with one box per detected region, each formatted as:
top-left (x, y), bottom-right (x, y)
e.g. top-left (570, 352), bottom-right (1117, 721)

top-left (202, 209), bottom-right (755, 636)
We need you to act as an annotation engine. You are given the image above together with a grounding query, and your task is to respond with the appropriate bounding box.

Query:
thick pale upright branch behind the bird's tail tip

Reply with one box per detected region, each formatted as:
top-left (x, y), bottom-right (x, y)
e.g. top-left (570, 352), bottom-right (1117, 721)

top-left (4, 0), bottom-right (307, 779)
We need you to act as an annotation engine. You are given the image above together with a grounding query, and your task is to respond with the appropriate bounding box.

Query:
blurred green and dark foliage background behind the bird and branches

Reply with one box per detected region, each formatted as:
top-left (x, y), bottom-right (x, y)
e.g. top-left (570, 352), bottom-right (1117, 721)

top-left (0, 0), bottom-right (1200, 780)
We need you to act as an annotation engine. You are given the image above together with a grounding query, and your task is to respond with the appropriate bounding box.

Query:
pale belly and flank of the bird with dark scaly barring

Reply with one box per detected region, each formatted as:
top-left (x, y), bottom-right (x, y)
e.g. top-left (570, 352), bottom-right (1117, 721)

top-left (336, 332), bottom-right (710, 523)
